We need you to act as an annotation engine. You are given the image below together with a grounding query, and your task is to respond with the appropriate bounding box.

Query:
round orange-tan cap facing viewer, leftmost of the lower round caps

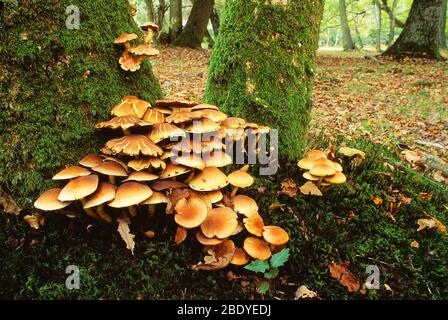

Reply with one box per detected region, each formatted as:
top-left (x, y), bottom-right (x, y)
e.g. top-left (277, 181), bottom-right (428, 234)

top-left (174, 198), bottom-right (207, 229)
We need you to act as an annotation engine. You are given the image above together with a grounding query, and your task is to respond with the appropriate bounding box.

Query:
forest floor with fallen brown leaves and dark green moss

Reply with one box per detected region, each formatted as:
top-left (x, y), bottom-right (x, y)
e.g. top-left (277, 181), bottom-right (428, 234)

top-left (0, 47), bottom-right (448, 299)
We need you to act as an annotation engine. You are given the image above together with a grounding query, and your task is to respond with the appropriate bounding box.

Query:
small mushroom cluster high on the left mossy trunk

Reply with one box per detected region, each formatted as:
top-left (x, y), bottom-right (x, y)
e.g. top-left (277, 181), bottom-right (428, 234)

top-left (114, 22), bottom-right (159, 72)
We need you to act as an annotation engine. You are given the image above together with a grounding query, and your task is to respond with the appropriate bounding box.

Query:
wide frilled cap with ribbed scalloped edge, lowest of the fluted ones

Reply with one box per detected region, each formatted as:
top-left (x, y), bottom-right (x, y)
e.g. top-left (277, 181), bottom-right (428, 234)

top-left (106, 134), bottom-right (163, 157)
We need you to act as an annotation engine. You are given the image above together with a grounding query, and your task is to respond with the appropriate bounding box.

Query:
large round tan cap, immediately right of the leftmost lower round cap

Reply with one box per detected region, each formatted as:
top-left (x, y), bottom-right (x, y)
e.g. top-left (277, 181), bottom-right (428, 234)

top-left (201, 207), bottom-right (238, 239)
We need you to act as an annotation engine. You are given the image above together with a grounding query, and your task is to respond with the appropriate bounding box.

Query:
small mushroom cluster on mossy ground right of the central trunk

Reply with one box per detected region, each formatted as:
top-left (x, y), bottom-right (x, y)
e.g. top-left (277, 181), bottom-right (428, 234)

top-left (297, 150), bottom-right (347, 196)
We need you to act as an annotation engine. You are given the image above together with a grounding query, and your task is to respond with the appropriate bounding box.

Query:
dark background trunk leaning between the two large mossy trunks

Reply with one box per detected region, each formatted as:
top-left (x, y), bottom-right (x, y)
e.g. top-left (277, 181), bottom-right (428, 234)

top-left (173, 0), bottom-right (215, 49)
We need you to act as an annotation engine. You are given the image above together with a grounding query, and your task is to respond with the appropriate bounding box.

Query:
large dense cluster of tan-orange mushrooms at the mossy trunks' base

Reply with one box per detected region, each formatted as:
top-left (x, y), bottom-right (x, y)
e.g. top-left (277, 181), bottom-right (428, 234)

top-left (35, 96), bottom-right (289, 270)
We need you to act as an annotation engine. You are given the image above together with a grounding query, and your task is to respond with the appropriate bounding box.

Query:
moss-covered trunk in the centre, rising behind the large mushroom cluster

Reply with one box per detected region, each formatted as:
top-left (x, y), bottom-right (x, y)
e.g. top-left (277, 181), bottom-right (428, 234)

top-left (205, 0), bottom-right (324, 159)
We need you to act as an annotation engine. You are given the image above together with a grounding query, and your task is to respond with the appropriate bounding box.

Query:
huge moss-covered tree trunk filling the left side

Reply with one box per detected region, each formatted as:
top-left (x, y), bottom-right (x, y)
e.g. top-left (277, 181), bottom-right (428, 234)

top-left (0, 0), bottom-right (161, 208)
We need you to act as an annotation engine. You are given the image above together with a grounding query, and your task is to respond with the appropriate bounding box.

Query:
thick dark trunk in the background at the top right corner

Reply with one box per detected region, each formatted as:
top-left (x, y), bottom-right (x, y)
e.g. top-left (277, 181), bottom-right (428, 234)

top-left (384, 0), bottom-right (443, 59)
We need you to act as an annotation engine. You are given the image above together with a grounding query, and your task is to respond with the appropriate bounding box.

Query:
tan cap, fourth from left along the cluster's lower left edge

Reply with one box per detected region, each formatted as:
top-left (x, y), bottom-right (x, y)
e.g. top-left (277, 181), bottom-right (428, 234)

top-left (108, 182), bottom-right (153, 208)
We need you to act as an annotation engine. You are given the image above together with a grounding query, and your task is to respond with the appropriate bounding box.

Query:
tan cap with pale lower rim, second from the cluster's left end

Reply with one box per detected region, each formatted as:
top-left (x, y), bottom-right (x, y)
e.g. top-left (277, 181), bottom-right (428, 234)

top-left (58, 174), bottom-right (99, 201)
